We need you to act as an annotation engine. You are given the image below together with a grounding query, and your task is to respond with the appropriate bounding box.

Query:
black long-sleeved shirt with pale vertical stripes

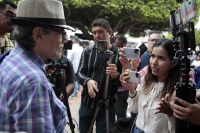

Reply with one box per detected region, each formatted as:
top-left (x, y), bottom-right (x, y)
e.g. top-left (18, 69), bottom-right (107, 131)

top-left (77, 45), bottom-right (121, 109)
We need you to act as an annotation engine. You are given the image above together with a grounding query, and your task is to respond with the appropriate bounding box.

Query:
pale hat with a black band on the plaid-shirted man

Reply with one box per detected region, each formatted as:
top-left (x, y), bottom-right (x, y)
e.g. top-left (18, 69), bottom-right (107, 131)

top-left (11, 0), bottom-right (75, 30)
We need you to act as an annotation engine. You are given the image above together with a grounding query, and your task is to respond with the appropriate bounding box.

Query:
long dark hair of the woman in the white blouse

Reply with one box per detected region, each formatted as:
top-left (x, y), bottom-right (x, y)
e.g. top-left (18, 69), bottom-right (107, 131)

top-left (143, 39), bottom-right (181, 98)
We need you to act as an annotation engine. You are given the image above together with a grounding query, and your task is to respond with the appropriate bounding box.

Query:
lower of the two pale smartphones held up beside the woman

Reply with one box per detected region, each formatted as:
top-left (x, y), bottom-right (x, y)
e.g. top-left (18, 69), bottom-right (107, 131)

top-left (127, 71), bottom-right (140, 84)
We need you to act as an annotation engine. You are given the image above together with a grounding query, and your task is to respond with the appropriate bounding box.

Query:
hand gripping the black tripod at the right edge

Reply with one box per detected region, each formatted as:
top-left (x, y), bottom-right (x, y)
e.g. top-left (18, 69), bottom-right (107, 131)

top-left (172, 97), bottom-right (200, 125)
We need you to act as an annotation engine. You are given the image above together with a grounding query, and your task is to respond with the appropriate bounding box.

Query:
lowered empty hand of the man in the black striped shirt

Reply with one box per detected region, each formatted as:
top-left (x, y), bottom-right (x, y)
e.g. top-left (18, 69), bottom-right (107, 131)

top-left (87, 79), bottom-right (98, 98)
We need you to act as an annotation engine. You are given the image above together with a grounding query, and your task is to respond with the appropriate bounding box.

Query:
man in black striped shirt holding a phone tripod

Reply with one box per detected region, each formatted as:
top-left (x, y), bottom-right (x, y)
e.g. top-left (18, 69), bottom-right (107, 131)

top-left (77, 19), bottom-right (121, 133)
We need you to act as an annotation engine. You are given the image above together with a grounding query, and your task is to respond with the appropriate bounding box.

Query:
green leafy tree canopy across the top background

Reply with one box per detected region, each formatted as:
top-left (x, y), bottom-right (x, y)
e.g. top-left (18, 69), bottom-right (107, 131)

top-left (9, 0), bottom-right (200, 39)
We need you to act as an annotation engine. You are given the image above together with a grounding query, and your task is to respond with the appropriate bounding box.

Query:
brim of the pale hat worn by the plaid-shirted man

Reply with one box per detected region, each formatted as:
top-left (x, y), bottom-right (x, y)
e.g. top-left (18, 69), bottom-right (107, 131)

top-left (10, 18), bottom-right (76, 31)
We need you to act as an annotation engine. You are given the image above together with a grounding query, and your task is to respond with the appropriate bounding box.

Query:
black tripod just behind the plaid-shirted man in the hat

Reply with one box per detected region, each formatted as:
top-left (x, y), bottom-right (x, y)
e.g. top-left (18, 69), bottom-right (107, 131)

top-left (50, 60), bottom-right (75, 133)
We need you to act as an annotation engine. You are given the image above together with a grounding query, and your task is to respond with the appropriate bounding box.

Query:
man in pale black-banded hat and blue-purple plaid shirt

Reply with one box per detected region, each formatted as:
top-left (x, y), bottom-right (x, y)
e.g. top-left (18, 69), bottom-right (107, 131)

top-left (0, 0), bottom-right (74, 133)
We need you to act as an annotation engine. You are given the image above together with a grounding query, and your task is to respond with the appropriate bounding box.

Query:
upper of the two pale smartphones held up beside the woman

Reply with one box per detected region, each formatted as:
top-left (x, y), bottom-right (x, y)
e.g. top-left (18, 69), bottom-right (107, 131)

top-left (123, 47), bottom-right (140, 59)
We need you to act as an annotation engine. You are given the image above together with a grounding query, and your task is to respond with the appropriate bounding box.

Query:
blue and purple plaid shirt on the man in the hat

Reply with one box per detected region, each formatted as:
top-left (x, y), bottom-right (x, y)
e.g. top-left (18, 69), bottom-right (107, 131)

top-left (0, 45), bottom-right (67, 133)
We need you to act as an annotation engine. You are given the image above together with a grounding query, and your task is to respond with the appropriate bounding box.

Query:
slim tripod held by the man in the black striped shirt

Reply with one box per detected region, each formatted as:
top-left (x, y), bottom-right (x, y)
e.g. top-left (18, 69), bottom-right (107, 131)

top-left (88, 50), bottom-right (114, 133)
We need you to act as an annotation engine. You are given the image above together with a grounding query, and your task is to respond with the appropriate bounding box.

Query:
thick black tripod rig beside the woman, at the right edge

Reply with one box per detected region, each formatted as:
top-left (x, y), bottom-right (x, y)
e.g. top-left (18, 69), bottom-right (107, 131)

top-left (171, 11), bottom-right (199, 133)
